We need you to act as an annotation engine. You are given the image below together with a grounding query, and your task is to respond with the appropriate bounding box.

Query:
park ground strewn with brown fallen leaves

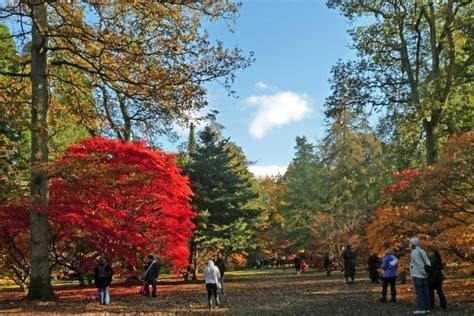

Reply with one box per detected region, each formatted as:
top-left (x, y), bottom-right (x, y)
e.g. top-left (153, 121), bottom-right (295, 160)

top-left (0, 269), bottom-right (474, 315)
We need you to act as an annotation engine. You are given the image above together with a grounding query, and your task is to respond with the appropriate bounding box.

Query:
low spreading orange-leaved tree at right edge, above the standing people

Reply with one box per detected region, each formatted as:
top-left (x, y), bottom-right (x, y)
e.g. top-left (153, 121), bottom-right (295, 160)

top-left (367, 132), bottom-right (474, 263)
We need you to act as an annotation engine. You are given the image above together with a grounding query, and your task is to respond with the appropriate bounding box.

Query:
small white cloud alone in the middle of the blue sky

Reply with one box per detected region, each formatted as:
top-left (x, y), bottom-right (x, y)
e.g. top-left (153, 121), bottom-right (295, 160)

top-left (246, 91), bottom-right (311, 139)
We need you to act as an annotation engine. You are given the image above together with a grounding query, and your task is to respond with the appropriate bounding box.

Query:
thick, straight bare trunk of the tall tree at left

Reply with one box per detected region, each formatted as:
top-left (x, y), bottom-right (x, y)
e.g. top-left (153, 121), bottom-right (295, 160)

top-left (27, 0), bottom-right (54, 300)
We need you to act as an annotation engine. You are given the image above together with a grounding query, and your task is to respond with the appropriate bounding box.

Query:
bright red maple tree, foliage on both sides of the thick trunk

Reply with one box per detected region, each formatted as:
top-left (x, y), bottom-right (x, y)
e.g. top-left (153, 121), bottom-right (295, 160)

top-left (0, 137), bottom-right (195, 285)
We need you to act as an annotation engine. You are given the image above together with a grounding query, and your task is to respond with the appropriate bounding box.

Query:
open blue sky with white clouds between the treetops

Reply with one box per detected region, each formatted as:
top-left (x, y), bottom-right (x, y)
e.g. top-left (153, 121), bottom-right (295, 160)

top-left (168, 0), bottom-right (355, 176)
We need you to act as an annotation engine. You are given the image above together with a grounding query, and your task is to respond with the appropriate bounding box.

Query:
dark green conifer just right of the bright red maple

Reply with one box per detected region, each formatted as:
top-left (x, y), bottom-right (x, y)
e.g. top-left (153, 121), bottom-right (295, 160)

top-left (188, 122), bottom-right (258, 276)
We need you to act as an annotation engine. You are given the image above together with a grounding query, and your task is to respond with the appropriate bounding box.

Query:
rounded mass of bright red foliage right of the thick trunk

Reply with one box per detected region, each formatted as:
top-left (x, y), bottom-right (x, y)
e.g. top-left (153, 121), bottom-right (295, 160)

top-left (49, 138), bottom-right (195, 269)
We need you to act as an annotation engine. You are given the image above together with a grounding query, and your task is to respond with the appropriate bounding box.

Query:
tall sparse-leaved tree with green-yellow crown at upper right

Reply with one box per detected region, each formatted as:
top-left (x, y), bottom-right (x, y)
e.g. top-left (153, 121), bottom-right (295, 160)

top-left (327, 0), bottom-right (474, 164)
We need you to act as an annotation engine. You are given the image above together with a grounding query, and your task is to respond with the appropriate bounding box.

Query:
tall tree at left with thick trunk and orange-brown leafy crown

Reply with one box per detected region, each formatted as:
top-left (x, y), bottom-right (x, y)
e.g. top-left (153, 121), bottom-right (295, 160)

top-left (0, 0), bottom-right (250, 300)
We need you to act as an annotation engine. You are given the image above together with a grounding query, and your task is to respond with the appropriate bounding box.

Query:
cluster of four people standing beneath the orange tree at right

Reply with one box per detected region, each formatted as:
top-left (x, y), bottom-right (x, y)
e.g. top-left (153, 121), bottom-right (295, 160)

top-left (367, 237), bottom-right (447, 314)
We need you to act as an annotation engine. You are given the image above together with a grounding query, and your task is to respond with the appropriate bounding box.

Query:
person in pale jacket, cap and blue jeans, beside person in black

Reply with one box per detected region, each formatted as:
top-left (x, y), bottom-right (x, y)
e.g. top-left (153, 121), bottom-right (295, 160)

top-left (410, 237), bottom-right (431, 314)
